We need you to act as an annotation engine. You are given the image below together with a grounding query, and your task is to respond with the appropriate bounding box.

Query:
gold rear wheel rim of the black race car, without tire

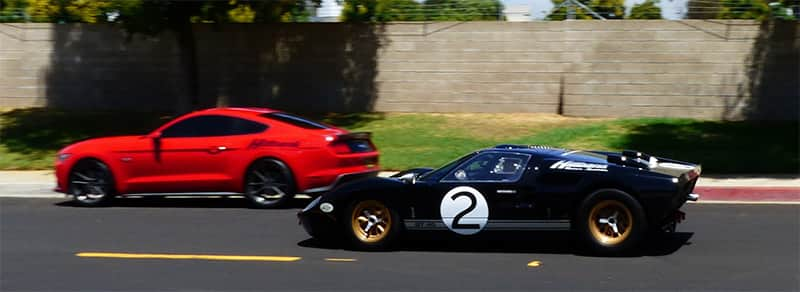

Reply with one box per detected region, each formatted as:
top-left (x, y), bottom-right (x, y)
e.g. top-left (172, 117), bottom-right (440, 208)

top-left (588, 200), bottom-right (634, 246)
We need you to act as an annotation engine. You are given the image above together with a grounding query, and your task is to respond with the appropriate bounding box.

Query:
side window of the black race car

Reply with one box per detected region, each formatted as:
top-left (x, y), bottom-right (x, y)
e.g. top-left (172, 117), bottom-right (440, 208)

top-left (442, 152), bottom-right (530, 182)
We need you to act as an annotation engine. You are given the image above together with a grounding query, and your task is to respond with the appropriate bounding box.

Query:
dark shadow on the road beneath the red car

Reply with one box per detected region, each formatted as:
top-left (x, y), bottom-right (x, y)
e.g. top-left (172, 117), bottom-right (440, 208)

top-left (54, 196), bottom-right (311, 210)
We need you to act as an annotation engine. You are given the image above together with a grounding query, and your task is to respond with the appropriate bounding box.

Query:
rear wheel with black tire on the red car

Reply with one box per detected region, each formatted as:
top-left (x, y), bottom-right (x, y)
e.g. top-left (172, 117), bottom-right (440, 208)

top-left (244, 158), bottom-right (295, 209)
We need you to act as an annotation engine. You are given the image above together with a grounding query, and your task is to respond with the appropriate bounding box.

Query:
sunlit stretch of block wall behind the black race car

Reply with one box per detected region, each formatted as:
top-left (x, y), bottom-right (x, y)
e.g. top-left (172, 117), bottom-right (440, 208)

top-left (376, 20), bottom-right (800, 119)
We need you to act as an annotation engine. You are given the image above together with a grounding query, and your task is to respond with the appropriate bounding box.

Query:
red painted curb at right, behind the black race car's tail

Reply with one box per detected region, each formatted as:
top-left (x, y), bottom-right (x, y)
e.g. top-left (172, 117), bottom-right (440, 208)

top-left (694, 187), bottom-right (800, 202)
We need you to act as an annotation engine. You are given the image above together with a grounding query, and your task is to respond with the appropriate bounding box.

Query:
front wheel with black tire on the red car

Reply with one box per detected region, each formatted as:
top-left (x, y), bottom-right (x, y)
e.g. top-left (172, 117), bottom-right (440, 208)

top-left (67, 159), bottom-right (116, 207)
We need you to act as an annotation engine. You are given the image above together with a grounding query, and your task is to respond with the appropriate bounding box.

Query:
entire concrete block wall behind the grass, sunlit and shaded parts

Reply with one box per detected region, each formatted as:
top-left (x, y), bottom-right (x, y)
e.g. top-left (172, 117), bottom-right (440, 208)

top-left (0, 20), bottom-right (800, 119)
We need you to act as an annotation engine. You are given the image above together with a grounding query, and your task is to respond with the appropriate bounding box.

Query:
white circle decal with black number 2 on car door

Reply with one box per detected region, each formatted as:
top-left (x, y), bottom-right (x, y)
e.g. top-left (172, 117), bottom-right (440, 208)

top-left (439, 186), bottom-right (489, 235)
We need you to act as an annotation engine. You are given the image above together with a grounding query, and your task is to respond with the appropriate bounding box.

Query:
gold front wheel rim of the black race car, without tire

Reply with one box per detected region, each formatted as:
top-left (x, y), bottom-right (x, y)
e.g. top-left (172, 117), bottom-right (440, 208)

top-left (351, 200), bottom-right (392, 243)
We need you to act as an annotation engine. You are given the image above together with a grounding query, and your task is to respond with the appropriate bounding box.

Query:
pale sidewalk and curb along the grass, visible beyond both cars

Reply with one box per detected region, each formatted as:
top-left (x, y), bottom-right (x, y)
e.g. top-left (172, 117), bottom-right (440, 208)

top-left (0, 170), bottom-right (800, 204)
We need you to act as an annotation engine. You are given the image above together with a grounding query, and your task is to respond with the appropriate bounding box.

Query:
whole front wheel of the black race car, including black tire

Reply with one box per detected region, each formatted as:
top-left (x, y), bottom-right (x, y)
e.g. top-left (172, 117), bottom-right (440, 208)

top-left (341, 200), bottom-right (402, 250)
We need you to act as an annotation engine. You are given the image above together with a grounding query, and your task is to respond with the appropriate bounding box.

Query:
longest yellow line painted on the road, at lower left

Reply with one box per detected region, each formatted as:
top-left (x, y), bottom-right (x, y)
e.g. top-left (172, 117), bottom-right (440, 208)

top-left (75, 252), bottom-right (301, 262)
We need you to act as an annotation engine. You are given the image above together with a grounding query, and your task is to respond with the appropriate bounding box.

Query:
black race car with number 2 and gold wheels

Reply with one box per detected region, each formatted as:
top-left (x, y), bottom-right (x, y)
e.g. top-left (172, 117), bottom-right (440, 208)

top-left (298, 145), bottom-right (700, 253)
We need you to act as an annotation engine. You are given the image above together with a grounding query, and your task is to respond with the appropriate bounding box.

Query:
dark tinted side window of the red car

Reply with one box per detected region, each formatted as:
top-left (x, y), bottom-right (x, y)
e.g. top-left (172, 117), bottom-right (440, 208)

top-left (161, 115), bottom-right (267, 138)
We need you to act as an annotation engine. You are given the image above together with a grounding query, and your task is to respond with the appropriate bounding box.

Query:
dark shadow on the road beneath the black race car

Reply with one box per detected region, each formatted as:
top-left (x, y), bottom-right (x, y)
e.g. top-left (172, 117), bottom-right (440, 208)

top-left (297, 231), bottom-right (694, 257)
